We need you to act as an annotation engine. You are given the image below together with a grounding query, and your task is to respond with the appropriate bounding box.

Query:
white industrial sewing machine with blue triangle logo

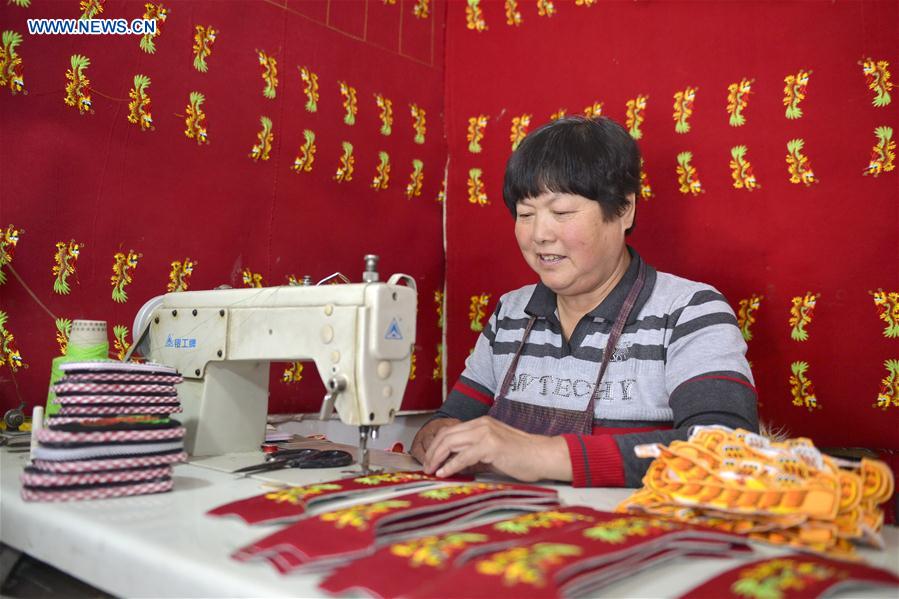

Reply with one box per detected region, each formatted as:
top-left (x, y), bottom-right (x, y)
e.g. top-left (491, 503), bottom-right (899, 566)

top-left (133, 255), bottom-right (417, 471)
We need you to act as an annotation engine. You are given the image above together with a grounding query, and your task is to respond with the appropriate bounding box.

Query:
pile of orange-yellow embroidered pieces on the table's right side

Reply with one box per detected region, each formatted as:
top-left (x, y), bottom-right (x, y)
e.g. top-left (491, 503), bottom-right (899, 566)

top-left (617, 426), bottom-right (894, 558)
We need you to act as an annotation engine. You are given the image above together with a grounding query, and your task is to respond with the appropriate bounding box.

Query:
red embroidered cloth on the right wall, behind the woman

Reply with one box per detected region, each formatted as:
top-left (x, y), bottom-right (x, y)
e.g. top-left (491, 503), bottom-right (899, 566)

top-left (446, 2), bottom-right (899, 450)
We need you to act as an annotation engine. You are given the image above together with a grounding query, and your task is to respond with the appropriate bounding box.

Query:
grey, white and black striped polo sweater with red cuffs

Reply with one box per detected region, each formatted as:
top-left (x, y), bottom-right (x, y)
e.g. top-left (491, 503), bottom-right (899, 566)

top-left (436, 248), bottom-right (758, 487)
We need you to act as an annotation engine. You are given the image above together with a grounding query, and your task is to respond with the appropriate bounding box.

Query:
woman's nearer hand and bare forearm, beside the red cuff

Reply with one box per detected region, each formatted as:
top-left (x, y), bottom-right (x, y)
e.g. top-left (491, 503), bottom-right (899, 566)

top-left (413, 416), bottom-right (571, 482)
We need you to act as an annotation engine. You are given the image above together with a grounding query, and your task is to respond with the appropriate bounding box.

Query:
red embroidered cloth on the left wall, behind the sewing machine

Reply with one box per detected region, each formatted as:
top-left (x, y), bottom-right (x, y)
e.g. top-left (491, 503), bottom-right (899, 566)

top-left (0, 0), bottom-right (446, 412)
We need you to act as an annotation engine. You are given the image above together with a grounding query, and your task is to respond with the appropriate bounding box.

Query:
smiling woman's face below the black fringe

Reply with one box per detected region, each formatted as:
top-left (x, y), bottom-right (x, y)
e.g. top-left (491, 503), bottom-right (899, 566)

top-left (515, 192), bottom-right (634, 297)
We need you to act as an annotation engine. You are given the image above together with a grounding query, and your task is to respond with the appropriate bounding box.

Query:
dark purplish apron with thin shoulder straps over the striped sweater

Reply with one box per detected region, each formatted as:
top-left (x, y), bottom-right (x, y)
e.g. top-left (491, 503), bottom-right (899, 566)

top-left (487, 260), bottom-right (646, 436)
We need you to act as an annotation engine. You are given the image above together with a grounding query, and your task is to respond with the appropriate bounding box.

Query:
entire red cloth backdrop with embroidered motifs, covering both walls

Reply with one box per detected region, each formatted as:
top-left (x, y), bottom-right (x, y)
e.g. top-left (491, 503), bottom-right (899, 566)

top-left (0, 0), bottom-right (899, 460)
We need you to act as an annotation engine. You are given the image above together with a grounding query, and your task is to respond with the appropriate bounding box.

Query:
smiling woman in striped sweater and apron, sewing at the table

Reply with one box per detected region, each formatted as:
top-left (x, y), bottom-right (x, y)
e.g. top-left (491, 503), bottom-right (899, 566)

top-left (412, 117), bottom-right (758, 486)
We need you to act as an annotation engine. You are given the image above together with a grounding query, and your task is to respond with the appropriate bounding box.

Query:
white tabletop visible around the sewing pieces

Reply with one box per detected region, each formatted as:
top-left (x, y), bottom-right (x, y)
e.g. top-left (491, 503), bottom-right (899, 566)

top-left (0, 449), bottom-right (899, 598)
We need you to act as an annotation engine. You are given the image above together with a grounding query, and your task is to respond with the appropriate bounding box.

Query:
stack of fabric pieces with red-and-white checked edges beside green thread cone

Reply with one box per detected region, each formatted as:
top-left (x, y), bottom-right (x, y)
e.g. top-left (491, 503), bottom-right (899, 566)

top-left (22, 361), bottom-right (187, 501)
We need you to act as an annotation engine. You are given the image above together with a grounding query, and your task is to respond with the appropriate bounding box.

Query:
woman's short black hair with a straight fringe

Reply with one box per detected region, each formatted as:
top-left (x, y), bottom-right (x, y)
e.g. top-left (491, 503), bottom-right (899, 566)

top-left (503, 116), bottom-right (640, 233)
